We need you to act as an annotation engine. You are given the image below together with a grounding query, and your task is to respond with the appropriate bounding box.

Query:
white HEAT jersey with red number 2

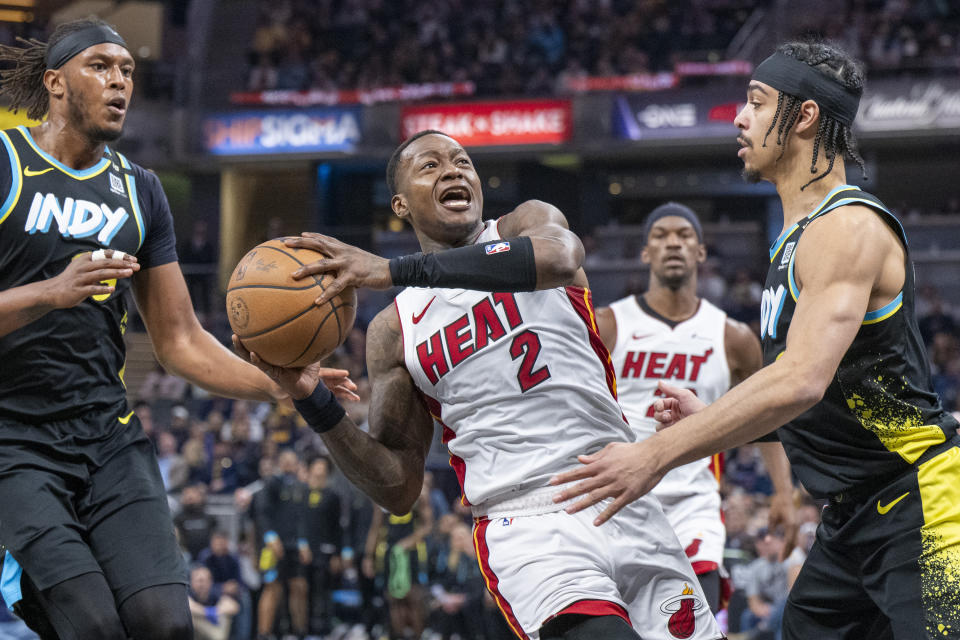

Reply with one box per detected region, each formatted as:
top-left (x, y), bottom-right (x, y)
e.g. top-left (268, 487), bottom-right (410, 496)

top-left (395, 221), bottom-right (636, 510)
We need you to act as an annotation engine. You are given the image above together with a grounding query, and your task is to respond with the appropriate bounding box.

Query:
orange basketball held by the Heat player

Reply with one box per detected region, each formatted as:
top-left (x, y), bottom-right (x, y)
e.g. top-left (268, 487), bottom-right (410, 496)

top-left (227, 238), bottom-right (357, 367)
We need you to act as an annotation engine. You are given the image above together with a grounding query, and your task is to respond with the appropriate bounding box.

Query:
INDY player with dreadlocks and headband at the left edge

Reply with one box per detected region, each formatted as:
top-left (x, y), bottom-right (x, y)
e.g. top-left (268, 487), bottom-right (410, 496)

top-left (0, 20), bottom-right (349, 640)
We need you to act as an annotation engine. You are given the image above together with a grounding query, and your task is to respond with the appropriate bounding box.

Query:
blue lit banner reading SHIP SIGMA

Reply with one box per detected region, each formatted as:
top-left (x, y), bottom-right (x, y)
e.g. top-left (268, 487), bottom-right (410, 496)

top-left (203, 107), bottom-right (360, 155)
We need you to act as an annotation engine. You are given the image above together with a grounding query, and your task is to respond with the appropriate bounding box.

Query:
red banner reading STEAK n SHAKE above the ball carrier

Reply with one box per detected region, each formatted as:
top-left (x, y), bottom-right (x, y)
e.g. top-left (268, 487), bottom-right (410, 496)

top-left (400, 100), bottom-right (573, 147)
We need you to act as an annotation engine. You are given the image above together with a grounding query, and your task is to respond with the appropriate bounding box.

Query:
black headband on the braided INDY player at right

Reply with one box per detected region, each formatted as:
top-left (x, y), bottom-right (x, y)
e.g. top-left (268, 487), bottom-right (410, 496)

top-left (753, 52), bottom-right (863, 127)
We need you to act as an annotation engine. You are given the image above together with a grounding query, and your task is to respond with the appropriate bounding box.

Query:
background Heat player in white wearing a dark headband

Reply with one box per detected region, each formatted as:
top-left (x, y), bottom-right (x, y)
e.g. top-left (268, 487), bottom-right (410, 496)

top-left (597, 202), bottom-right (793, 611)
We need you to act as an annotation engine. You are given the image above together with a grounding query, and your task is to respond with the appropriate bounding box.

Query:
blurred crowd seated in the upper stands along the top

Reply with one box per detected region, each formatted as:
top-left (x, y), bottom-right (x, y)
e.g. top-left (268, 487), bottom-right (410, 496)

top-left (248, 0), bottom-right (960, 96)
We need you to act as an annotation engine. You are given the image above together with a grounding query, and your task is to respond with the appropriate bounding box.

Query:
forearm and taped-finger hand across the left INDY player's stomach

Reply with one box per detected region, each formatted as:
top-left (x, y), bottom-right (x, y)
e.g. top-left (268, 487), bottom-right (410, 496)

top-left (0, 250), bottom-right (140, 338)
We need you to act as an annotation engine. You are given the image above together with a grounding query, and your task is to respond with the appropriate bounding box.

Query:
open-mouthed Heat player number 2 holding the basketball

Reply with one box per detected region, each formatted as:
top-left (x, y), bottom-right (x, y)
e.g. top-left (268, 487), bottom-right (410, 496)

top-left (237, 131), bottom-right (722, 640)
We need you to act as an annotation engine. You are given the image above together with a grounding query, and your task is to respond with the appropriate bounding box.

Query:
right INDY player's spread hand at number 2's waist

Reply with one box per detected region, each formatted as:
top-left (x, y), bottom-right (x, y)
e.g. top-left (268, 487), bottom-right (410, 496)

top-left (550, 441), bottom-right (665, 527)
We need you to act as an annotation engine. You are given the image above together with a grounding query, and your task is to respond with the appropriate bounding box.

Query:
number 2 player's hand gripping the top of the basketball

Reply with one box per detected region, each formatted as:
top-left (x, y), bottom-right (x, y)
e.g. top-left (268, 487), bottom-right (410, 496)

top-left (284, 232), bottom-right (393, 306)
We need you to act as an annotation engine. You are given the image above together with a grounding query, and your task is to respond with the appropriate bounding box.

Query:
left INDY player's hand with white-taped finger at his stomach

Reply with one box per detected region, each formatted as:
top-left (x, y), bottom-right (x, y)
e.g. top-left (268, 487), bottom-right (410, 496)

top-left (46, 249), bottom-right (140, 309)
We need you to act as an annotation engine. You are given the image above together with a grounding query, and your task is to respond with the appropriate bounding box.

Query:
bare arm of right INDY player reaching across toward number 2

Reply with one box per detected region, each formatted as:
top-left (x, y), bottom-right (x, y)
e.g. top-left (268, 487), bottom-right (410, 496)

top-left (553, 207), bottom-right (903, 525)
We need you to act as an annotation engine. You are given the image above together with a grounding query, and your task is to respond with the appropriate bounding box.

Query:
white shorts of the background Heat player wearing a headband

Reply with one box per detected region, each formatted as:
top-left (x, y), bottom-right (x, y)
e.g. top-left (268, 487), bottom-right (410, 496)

top-left (655, 491), bottom-right (727, 575)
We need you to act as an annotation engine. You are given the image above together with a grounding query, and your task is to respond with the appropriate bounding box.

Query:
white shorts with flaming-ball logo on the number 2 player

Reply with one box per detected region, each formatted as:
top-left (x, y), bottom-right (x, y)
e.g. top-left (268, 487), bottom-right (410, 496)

top-left (473, 487), bottom-right (723, 640)
